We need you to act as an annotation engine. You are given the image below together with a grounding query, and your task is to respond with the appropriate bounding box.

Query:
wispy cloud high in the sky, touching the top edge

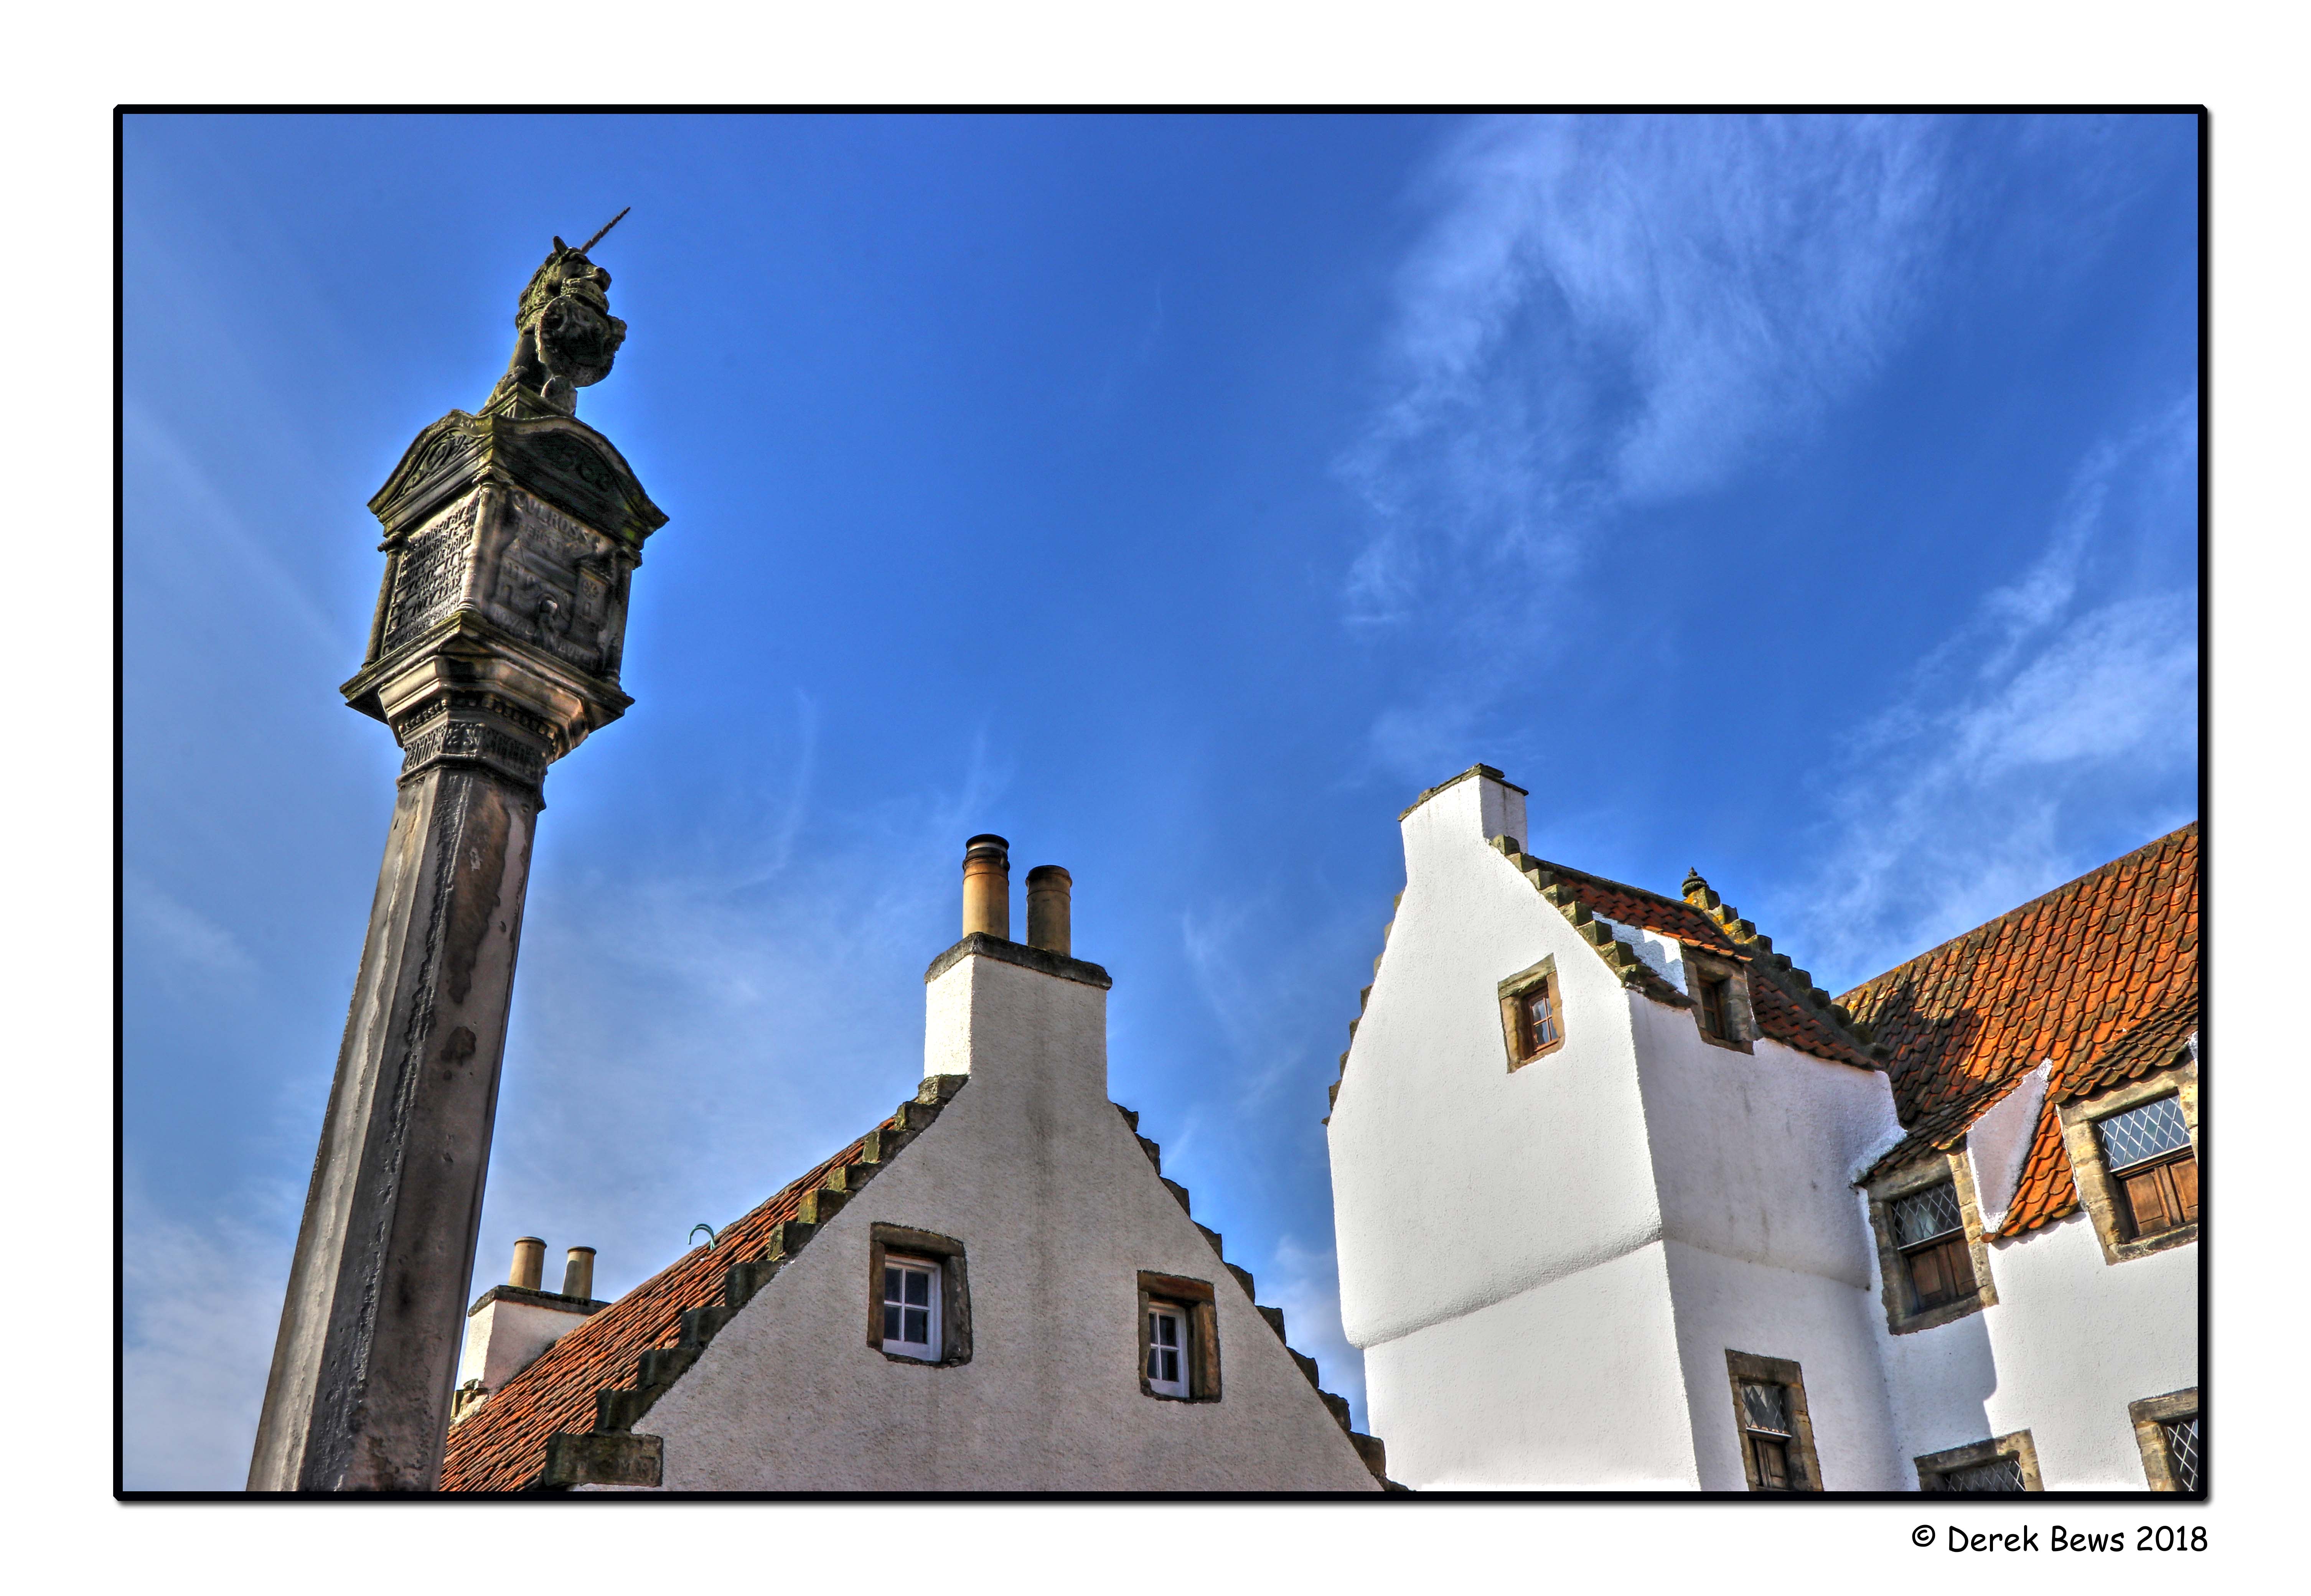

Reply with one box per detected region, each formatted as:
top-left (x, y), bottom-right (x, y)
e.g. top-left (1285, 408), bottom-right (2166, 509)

top-left (1343, 118), bottom-right (1950, 624)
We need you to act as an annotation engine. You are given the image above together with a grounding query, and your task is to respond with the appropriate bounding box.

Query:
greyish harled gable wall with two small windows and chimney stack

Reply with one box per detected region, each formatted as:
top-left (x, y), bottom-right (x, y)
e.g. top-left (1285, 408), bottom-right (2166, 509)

top-left (605, 954), bottom-right (1377, 1490)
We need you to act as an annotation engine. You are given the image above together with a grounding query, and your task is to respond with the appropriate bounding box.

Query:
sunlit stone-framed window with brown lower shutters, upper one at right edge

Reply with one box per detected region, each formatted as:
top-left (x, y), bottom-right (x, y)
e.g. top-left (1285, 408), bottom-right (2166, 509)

top-left (2057, 1056), bottom-right (2200, 1263)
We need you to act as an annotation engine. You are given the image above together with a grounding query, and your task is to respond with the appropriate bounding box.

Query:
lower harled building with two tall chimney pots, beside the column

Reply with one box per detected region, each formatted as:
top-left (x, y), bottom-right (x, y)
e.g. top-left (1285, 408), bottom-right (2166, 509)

top-left (442, 836), bottom-right (1384, 1492)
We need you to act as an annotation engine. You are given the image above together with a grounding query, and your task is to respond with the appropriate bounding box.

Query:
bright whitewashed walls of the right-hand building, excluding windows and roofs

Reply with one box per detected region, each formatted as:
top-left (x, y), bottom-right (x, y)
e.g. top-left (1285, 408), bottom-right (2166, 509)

top-left (1331, 776), bottom-right (2198, 1490)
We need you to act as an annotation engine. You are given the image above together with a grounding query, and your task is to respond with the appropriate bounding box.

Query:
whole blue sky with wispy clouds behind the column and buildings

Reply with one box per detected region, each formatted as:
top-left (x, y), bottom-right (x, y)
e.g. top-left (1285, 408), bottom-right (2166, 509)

top-left (122, 118), bottom-right (2198, 1485)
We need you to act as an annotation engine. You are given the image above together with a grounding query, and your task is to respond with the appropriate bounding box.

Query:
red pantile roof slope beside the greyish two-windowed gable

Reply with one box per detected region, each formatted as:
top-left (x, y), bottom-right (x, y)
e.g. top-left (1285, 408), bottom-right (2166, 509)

top-left (442, 1115), bottom-right (899, 1490)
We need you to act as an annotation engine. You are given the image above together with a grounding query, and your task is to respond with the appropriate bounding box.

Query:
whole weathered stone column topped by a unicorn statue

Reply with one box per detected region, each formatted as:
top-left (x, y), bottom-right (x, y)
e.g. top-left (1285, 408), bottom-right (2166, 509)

top-left (250, 242), bottom-right (666, 1490)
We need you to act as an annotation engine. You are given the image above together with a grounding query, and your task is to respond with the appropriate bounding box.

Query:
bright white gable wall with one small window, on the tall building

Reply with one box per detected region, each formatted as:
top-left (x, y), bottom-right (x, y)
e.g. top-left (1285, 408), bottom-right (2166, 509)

top-left (1329, 774), bottom-right (1691, 1487)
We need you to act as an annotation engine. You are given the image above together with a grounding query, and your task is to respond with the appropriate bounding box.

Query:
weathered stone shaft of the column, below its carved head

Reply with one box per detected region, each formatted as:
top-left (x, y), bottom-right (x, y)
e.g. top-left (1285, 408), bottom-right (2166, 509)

top-left (250, 764), bottom-right (539, 1490)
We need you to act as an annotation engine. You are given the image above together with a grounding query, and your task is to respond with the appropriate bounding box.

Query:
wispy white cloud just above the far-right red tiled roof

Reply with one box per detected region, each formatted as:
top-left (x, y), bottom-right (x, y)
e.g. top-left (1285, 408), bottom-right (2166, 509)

top-left (1775, 402), bottom-right (2198, 986)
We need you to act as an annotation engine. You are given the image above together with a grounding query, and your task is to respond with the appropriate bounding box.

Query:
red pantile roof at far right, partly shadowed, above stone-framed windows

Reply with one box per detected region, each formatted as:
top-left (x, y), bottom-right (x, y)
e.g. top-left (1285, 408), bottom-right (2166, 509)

top-left (1840, 820), bottom-right (2200, 1236)
